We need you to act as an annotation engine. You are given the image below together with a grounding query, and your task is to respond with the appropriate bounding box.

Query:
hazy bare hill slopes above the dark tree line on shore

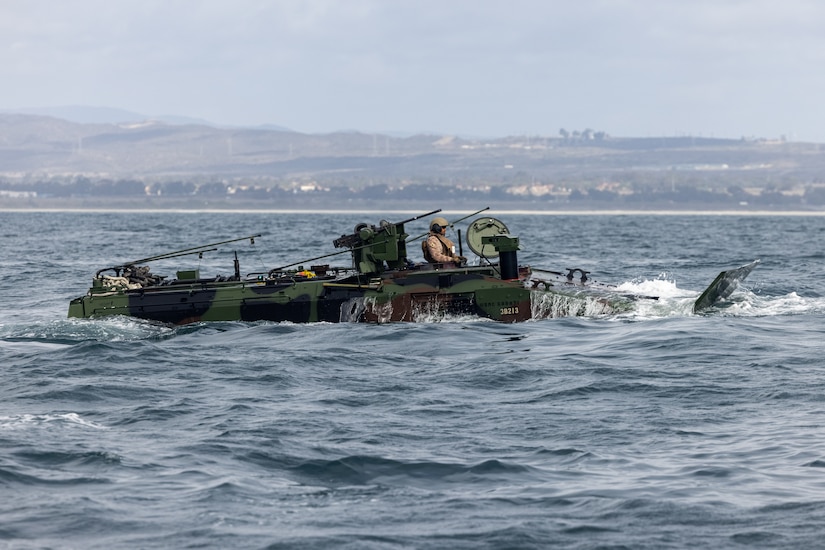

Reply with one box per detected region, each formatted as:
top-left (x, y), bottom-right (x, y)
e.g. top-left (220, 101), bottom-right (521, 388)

top-left (0, 114), bottom-right (825, 178)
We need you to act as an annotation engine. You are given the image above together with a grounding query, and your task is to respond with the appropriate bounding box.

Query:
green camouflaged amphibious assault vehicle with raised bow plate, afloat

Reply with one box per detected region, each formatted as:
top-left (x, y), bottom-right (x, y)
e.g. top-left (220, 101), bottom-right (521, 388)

top-left (69, 208), bottom-right (759, 324)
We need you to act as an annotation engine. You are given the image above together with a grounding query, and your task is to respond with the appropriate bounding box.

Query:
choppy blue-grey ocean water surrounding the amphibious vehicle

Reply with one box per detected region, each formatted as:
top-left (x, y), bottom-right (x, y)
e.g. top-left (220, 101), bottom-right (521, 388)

top-left (0, 211), bottom-right (825, 549)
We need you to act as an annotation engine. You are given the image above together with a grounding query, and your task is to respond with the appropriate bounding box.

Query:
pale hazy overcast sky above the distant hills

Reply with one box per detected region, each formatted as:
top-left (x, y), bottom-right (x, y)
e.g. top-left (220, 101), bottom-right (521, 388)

top-left (0, 0), bottom-right (825, 142)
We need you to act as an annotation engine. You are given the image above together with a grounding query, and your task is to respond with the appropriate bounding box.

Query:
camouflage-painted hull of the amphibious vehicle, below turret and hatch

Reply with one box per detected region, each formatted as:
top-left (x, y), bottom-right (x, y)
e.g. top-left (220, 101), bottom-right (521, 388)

top-left (69, 268), bottom-right (632, 324)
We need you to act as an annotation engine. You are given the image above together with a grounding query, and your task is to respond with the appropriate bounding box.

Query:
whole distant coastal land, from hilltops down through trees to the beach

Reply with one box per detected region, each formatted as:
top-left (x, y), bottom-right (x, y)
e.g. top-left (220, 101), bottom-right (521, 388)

top-left (0, 113), bottom-right (825, 211)
